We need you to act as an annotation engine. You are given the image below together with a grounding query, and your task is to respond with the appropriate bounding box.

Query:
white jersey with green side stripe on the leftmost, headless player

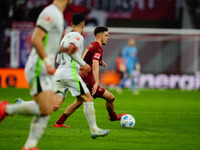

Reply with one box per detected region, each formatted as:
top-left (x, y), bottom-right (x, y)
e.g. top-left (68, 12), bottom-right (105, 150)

top-left (25, 4), bottom-right (64, 79)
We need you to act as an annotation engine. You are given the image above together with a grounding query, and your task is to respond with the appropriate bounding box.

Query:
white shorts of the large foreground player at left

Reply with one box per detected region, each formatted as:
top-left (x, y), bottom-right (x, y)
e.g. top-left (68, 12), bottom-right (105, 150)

top-left (28, 75), bottom-right (56, 96)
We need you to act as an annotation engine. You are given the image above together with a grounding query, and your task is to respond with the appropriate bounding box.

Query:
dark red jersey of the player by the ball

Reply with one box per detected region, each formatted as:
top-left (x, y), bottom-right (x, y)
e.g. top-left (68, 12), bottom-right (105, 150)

top-left (82, 41), bottom-right (103, 79)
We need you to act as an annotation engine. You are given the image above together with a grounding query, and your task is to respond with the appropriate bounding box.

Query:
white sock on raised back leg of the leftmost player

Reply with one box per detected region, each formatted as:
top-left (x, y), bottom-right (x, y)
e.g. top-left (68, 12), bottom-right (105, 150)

top-left (5, 101), bottom-right (40, 116)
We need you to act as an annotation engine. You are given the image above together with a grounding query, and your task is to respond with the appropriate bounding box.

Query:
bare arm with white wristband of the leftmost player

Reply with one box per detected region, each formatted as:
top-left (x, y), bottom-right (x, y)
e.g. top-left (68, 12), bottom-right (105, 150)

top-left (31, 27), bottom-right (55, 75)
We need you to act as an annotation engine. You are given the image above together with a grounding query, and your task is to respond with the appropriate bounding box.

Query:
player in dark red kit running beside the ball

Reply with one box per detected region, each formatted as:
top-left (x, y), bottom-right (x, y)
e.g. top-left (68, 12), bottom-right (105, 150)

top-left (54, 27), bottom-right (124, 127)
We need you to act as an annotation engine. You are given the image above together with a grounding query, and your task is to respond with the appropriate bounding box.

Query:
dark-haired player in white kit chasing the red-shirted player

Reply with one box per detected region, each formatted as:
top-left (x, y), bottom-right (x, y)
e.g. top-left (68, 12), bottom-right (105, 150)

top-left (54, 14), bottom-right (109, 139)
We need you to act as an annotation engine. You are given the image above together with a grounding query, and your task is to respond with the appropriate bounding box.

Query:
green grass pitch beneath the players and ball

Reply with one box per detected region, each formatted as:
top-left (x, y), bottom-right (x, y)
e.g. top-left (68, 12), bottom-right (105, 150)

top-left (0, 88), bottom-right (200, 150)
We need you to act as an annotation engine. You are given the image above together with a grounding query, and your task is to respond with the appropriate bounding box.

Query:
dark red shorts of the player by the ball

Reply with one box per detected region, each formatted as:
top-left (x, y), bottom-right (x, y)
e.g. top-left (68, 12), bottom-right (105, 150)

top-left (83, 77), bottom-right (106, 99)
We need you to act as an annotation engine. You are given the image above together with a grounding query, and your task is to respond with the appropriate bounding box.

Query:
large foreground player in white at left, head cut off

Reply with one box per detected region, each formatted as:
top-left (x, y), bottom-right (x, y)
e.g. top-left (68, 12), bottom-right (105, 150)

top-left (0, 0), bottom-right (71, 150)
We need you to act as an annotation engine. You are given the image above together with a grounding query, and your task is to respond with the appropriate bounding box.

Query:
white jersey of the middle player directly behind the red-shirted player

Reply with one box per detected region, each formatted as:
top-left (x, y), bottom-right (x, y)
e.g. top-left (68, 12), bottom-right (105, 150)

top-left (54, 32), bottom-right (84, 81)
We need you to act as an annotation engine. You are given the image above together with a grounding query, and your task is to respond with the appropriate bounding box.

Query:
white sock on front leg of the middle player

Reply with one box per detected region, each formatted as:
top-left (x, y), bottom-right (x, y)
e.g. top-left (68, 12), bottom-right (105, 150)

top-left (83, 102), bottom-right (98, 132)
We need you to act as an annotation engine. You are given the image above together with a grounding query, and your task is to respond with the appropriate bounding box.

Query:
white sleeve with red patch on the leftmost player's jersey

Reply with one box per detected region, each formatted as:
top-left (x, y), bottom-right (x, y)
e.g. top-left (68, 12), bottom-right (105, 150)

top-left (36, 11), bottom-right (56, 32)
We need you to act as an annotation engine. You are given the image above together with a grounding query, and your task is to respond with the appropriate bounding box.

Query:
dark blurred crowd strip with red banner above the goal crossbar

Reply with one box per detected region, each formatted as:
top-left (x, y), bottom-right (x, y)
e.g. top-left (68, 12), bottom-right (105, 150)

top-left (0, 0), bottom-right (200, 28)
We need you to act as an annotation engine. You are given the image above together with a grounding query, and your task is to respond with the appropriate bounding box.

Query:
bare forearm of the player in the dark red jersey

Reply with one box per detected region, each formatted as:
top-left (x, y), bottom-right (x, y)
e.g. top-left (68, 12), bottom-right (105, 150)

top-left (92, 60), bottom-right (99, 95)
